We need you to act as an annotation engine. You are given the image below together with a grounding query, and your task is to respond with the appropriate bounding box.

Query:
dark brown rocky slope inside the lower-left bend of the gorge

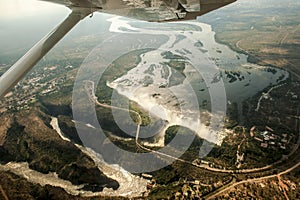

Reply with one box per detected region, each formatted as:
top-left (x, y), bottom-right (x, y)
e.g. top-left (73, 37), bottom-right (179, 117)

top-left (0, 108), bottom-right (119, 195)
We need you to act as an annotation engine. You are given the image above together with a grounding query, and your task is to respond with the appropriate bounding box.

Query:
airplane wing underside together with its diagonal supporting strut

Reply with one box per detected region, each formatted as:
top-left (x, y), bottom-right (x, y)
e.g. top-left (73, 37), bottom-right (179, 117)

top-left (0, 0), bottom-right (236, 98)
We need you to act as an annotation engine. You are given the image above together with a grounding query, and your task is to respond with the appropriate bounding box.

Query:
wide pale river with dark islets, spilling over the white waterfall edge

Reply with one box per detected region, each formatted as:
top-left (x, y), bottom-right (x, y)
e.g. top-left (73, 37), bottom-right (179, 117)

top-left (103, 17), bottom-right (289, 144)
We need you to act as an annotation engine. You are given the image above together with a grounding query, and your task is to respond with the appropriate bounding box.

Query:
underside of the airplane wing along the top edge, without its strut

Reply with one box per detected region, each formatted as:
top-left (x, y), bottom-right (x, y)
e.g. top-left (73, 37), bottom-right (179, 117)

top-left (43, 0), bottom-right (236, 22)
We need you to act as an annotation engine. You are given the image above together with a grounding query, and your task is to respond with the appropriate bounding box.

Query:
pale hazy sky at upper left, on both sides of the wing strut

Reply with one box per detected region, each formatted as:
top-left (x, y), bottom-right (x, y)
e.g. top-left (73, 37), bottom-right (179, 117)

top-left (0, 0), bottom-right (108, 56)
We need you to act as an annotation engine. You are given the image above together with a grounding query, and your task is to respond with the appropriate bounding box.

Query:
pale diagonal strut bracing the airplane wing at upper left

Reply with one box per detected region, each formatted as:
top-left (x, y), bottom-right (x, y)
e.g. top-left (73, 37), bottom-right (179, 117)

top-left (0, 8), bottom-right (94, 98)
